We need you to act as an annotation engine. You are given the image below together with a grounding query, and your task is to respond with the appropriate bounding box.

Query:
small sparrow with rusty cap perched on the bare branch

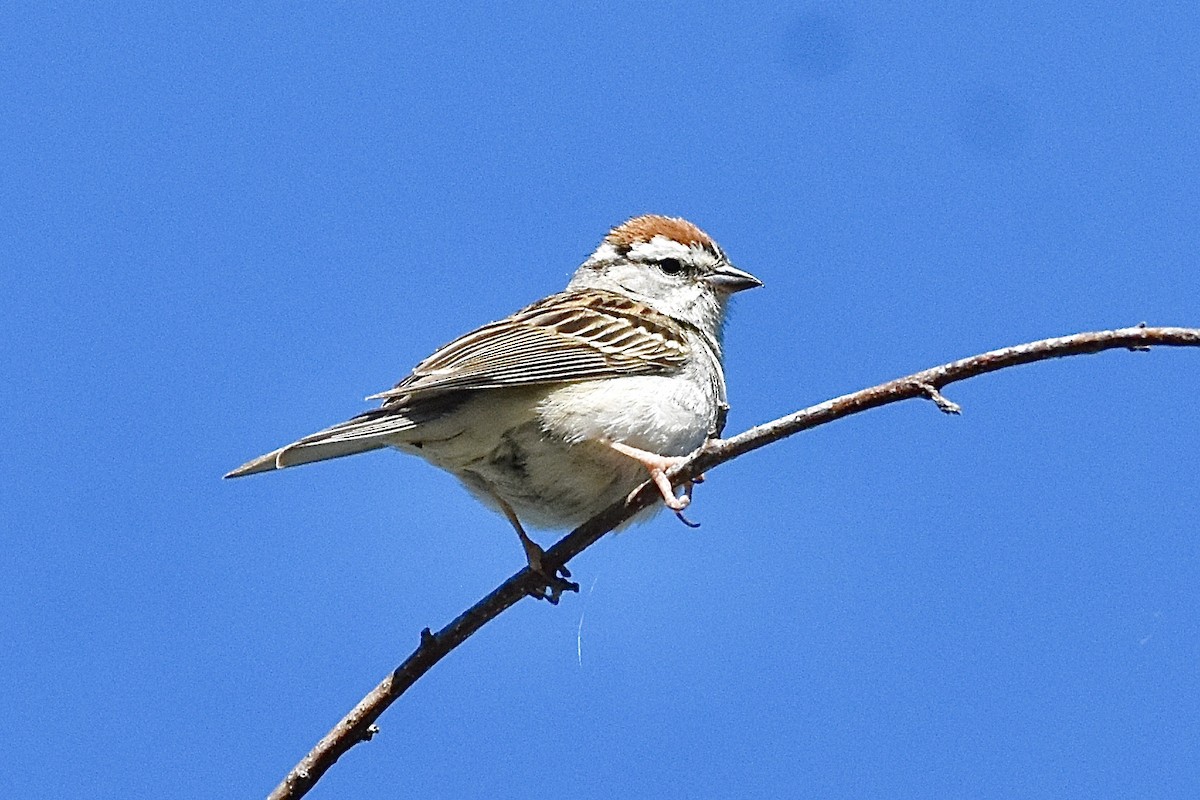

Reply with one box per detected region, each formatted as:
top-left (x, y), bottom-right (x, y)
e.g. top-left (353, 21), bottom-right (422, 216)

top-left (226, 215), bottom-right (762, 600)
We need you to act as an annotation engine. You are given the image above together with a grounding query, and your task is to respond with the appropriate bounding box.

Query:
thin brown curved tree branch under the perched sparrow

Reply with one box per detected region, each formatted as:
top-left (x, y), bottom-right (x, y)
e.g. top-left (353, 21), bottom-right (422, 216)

top-left (269, 324), bottom-right (1200, 800)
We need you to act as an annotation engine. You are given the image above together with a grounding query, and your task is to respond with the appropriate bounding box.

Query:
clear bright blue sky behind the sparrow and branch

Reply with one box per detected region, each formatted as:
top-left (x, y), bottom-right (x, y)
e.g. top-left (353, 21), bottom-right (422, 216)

top-left (0, 2), bottom-right (1200, 799)
